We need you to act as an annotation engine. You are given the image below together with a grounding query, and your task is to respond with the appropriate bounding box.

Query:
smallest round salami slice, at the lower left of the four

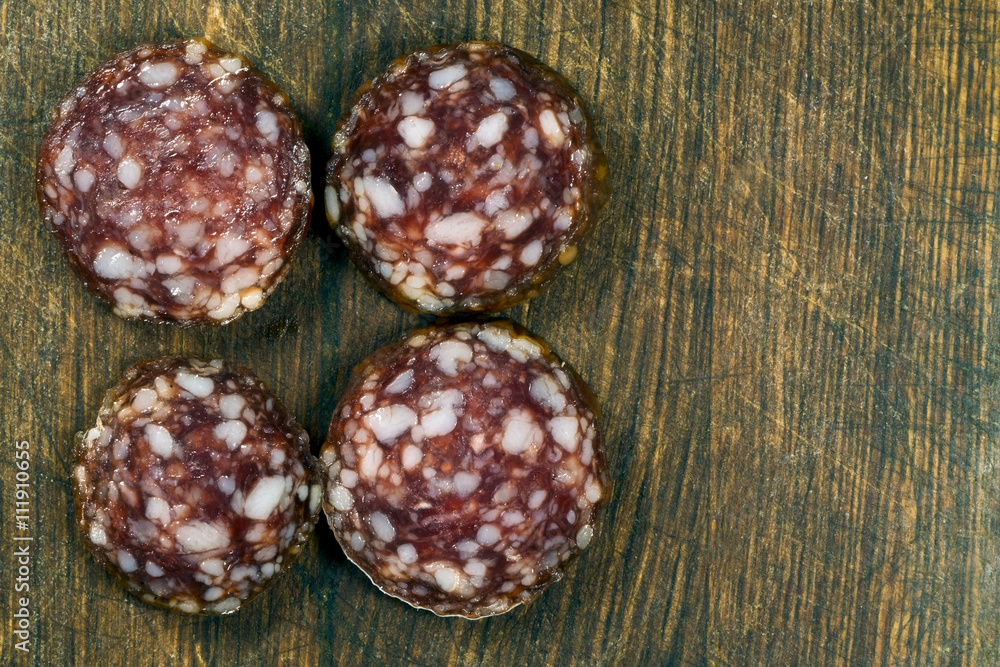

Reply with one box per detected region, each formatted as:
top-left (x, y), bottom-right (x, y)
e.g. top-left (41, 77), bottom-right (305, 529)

top-left (73, 357), bottom-right (322, 614)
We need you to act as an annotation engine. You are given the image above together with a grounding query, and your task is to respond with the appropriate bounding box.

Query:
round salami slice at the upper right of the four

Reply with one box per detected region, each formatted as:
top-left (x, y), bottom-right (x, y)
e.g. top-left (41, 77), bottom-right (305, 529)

top-left (325, 42), bottom-right (607, 314)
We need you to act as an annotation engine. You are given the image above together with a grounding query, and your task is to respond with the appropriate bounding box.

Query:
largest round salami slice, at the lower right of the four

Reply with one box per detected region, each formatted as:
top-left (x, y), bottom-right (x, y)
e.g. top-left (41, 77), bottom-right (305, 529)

top-left (320, 322), bottom-right (608, 618)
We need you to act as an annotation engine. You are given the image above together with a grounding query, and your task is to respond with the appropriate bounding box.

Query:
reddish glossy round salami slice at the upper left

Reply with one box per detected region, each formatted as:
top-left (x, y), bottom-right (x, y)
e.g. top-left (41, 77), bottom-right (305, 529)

top-left (37, 39), bottom-right (312, 325)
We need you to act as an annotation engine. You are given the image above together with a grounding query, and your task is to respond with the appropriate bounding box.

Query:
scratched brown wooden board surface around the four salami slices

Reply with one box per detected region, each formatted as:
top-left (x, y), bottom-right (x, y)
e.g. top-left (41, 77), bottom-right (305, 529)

top-left (0, 0), bottom-right (1000, 665)
